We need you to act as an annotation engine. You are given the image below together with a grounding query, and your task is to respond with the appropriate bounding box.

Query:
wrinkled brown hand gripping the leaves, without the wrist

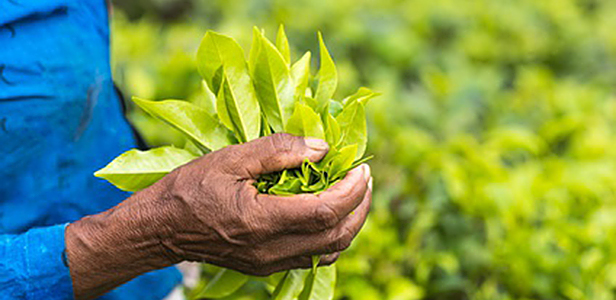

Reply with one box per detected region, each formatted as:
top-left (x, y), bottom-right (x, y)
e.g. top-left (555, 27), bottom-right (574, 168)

top-left (156, 134), bottom-right (371, 275)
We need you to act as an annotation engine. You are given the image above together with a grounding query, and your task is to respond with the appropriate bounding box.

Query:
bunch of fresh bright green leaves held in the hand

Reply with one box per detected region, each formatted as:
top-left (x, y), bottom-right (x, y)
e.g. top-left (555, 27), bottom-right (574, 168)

top-left (95, 26), bottom-right (377, 300)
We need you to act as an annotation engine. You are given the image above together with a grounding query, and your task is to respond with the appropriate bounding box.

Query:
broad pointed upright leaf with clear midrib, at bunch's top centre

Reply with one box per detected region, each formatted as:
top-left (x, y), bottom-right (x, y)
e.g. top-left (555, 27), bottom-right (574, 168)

top-left (253, 29), bottom-right (295, 132)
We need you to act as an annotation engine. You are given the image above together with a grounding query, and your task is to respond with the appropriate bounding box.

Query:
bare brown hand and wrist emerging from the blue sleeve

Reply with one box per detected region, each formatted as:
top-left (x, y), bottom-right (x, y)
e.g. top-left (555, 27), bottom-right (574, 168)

top-left (66, 134), bottom-right (372, 298)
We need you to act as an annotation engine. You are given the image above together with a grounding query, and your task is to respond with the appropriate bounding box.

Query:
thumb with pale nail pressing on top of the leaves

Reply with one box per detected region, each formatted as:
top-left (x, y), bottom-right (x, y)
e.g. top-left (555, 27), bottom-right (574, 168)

top-left (223, 133), bottom-right (329, 178)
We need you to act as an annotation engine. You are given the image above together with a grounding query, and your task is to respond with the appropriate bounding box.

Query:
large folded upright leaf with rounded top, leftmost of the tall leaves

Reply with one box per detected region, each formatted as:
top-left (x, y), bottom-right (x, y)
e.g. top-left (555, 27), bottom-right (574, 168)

top-left (197, 31), bottom-right (261, 142)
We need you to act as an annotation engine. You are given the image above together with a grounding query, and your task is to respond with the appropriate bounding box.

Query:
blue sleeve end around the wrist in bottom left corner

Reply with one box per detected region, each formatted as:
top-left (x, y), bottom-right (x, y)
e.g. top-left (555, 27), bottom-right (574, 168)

top-left (0, 224), bottom-right (73, 300)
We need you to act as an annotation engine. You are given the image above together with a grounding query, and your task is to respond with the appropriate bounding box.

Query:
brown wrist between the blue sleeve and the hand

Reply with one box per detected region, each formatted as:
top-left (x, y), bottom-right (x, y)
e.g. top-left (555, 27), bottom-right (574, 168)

top-left (65, 180), bottom-right (180, 299)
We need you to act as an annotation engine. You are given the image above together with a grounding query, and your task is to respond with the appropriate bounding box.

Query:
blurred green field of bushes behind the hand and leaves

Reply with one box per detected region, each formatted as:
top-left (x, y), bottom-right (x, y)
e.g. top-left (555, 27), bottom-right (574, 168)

top-left (113, 0), bottom-right (616, 300)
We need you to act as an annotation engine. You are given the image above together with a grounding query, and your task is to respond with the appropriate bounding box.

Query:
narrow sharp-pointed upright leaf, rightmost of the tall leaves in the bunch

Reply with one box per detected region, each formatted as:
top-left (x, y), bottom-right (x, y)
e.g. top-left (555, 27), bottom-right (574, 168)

top-left (315, 32), bottom-right (338, 114)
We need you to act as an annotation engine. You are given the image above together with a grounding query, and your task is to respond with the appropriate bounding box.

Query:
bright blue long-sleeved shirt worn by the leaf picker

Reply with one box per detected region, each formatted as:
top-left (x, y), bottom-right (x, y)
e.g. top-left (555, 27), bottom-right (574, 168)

top-left (0, 0), bottom-right (181, 299)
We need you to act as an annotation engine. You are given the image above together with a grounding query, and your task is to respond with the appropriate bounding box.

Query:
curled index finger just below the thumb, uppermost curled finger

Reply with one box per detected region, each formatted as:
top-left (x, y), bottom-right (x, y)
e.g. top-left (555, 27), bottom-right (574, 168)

top-left (256, 164), bottom-right (370, 233)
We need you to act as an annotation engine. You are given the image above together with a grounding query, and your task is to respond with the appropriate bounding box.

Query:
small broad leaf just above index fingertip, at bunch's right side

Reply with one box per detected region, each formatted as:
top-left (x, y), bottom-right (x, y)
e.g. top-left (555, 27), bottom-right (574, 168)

top-left (336, 101), bottom-right (368, 159)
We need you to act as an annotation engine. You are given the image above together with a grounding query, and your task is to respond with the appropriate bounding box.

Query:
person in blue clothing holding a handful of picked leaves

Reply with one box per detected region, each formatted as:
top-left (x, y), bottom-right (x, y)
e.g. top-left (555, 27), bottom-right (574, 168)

top-left (0, 0), bottom-right (372, 299)
